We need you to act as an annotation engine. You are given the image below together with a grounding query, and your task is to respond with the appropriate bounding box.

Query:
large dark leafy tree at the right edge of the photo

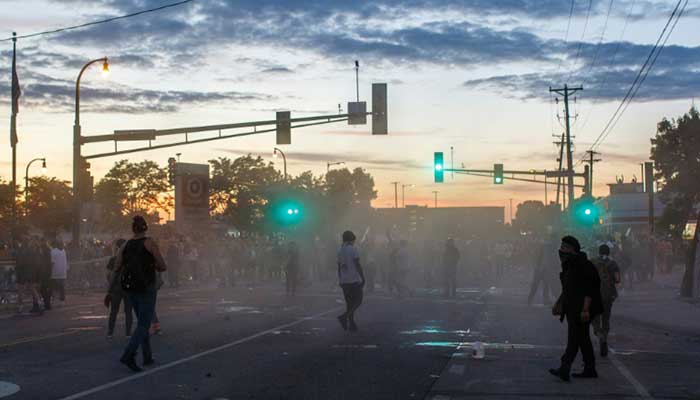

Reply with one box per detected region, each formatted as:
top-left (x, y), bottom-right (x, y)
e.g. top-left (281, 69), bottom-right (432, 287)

top-left (651, 107), bottom-right (700, 236)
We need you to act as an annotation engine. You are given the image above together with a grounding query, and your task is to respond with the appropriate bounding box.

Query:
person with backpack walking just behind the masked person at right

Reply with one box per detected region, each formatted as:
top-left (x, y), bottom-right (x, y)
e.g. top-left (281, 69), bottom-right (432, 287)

top-left (593, 244), bottom-right (621, 357)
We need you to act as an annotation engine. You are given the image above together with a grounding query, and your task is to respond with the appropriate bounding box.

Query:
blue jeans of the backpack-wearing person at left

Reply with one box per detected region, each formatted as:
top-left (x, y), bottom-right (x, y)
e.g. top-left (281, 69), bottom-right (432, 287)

top-left (122, 286), bottom-right (156, 360)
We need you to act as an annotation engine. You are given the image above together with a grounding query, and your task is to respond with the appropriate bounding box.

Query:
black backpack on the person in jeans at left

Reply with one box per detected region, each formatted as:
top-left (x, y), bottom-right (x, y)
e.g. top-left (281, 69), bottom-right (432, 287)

top-left (121, 238), bottom-right (155, 293)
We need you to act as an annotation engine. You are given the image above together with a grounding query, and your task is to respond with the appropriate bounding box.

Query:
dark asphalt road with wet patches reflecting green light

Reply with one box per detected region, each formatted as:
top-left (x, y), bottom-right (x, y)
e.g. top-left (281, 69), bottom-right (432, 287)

top-left (0, 285), bottom-right (700, 400)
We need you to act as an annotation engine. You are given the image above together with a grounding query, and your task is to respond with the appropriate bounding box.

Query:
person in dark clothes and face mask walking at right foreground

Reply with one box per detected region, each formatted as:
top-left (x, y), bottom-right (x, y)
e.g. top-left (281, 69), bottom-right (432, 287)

top-left (549, 236), bottom-right (603, 381)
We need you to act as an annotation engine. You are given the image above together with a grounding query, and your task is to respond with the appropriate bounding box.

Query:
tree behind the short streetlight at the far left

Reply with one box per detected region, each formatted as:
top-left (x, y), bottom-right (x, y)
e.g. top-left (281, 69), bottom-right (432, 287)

top-left (26, 176), bottom-right (73, 233)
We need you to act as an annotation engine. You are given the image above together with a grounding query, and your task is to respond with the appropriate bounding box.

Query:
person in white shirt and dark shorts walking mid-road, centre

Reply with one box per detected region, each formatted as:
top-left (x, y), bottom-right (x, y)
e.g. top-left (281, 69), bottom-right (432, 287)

top-left (338, 231), bottom-right (365, 332)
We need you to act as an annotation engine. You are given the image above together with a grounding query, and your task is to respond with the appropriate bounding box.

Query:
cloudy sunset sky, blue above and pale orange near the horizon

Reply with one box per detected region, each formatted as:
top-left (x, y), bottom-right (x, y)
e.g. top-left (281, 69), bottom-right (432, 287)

top-left (0, 0), bottom-right (700, 218)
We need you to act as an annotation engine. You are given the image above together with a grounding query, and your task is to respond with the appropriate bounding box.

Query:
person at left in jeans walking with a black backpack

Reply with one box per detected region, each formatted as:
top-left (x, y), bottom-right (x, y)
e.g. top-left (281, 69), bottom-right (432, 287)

top-left (105, 215), bottom-right (167, 372)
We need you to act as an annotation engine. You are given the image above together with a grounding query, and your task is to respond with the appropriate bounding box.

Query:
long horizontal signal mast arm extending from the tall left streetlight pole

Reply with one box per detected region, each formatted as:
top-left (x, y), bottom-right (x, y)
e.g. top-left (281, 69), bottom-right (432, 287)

top-left (82, 113), bottom-right (372, 159)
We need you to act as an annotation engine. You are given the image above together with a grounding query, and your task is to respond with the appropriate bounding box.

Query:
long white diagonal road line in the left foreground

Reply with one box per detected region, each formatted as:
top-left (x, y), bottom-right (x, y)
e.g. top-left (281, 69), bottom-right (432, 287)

top-left (60, 307), bottom-right (344, 400)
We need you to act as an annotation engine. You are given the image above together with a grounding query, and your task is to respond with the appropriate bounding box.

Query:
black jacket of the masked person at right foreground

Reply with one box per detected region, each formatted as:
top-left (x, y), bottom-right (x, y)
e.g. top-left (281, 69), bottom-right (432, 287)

top-left (559, 252), bottom-right (603, 319)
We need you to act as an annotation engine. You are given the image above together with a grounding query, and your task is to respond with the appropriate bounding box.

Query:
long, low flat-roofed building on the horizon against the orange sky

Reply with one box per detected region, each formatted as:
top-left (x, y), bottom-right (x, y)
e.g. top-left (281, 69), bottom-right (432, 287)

top-left (373, 206), bottom-right (505, 239)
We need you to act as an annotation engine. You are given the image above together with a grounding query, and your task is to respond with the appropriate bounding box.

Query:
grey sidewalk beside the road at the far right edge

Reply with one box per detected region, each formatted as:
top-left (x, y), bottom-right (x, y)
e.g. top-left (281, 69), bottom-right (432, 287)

top-left (613, 268), bottom-right (700, 335)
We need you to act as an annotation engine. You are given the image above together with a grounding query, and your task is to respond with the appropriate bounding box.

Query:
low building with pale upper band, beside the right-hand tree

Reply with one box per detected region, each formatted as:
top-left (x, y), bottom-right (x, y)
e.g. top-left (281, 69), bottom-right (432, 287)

top-left (599, 182), bottom-right (664, 232)
